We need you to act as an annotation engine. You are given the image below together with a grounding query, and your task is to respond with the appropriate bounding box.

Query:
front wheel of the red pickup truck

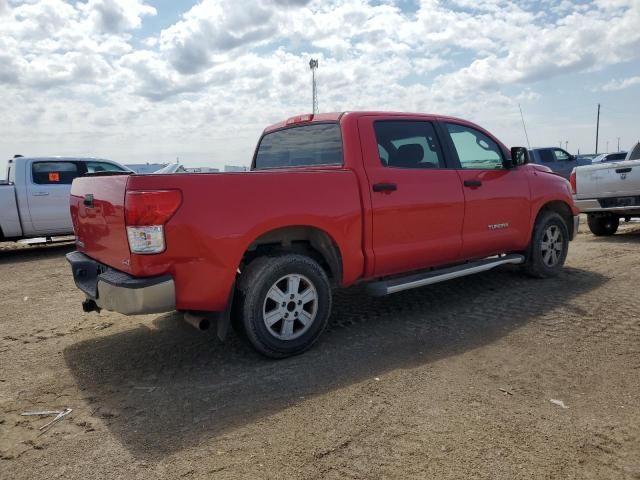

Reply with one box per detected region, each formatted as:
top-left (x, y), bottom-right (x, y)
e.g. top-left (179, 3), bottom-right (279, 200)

top-left (524, 211), bottom-right (569, 278)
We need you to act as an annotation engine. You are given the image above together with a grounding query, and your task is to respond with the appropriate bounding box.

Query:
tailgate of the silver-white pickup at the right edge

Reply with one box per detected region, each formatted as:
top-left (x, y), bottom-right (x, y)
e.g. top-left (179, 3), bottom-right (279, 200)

top-left (576, 160), bottom-right (640, 200)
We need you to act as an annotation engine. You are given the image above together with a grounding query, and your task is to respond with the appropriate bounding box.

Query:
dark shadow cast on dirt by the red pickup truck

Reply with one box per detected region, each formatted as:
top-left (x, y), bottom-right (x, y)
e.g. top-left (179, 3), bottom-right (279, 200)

top-left (64, 268), bottom-right (606, 461)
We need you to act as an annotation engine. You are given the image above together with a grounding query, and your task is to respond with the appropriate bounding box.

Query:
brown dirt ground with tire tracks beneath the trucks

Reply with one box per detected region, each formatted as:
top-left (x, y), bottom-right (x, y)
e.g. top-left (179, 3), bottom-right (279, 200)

top-left (0, 224), bottom-right (640, 479)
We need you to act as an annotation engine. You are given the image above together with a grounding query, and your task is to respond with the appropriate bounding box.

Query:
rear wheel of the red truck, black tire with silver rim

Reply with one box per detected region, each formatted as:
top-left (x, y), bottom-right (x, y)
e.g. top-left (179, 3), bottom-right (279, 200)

top-left (237, 254), bottom-right (332, 358)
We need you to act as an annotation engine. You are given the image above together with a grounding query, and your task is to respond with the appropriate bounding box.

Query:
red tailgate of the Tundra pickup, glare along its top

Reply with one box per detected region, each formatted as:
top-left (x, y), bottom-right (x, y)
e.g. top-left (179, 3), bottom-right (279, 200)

top-left (70, 175), bottom-right (131, 272)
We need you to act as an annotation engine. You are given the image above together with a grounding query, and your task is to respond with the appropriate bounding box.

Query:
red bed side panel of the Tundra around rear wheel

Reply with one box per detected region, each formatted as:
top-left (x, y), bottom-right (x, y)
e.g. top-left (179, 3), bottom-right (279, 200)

top-left (127, 169), bottom-right (363, 311)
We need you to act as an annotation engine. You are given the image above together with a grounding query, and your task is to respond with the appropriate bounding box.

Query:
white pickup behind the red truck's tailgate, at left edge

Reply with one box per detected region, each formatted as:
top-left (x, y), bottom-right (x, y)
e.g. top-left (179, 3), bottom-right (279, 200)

top-left (0, 155), bottom-right (130, 241)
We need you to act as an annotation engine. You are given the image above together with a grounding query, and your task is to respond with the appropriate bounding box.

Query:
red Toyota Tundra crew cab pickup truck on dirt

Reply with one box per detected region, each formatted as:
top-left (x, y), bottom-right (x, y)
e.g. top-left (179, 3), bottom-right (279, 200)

top-left (67, 112), bottom-right (578, 357)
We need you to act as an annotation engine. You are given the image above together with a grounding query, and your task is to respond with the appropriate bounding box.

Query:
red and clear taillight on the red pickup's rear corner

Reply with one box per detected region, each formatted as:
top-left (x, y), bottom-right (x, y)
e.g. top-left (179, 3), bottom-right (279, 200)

top-left (124, 190), bottom-right (182, 254)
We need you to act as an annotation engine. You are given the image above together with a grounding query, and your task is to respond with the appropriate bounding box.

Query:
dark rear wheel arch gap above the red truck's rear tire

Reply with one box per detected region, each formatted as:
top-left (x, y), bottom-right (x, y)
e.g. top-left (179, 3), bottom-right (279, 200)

top-left (240, 225), bottom-right (343, 286)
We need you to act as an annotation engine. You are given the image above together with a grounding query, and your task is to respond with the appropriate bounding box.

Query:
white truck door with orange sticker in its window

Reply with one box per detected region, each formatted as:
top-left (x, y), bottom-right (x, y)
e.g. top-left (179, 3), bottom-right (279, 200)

top-left (26, 160), bottom-right (82, 235)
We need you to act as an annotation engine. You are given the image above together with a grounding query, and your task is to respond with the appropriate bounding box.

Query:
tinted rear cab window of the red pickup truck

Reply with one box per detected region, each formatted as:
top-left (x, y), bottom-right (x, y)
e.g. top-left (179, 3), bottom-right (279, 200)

top-left (254, 123), bottom-right (342, 170)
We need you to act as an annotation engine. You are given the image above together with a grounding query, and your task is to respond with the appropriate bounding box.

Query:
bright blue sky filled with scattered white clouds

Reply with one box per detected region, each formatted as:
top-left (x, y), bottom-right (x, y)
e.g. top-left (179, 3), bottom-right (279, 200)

top-left (0, 0), bottom-right (640, 168)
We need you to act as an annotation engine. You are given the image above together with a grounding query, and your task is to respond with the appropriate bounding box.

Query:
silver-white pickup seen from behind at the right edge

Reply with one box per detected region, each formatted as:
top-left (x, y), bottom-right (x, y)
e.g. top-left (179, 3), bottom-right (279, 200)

top-left (569, 143), bottom-right (640, 236)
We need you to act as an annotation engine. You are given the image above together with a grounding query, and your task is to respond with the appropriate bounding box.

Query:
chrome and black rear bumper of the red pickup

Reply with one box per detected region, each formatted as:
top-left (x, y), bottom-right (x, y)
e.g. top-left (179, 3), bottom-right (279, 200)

top-left (67, 252), bottom-right (176, 315)
